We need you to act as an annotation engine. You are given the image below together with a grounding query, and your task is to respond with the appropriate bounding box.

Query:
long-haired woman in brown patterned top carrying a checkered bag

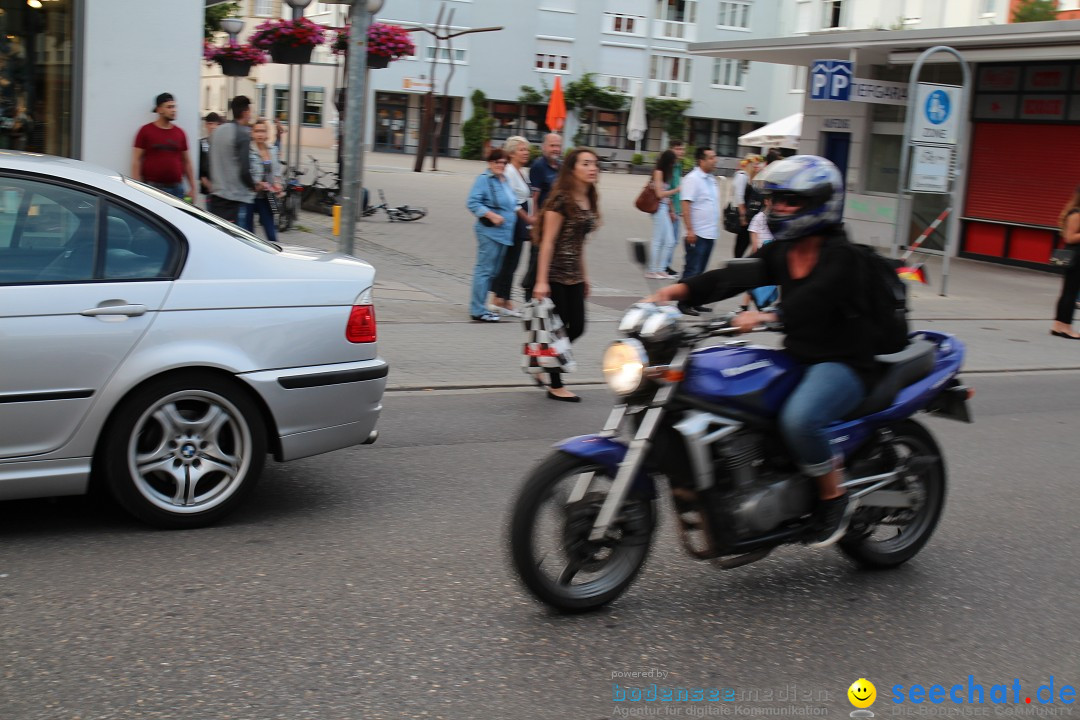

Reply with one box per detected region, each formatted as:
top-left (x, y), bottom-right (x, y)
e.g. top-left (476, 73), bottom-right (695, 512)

top-left (532, 148), bottom-right (600, 403)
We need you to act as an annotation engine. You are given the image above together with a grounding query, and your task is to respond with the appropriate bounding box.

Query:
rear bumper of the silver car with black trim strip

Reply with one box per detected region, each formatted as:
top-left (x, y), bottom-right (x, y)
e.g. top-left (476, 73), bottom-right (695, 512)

top-left (239, 358), bottom-right (390, 461)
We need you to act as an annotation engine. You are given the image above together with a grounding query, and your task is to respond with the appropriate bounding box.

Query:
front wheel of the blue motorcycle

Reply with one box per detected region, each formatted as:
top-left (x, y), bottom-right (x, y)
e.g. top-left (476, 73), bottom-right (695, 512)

top-left (510, 452), bottom-right (656, 613)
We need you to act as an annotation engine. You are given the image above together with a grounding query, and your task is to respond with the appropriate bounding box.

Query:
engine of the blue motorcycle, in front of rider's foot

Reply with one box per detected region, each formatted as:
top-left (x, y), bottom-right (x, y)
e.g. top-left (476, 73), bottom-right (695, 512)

top-left (714, 433), bottom-right (816, 538)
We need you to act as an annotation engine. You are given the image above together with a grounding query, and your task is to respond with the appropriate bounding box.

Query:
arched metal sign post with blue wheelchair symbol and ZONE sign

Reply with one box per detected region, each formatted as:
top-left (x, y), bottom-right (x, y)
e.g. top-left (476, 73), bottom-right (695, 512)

top-left (891, 45), bottom-right (971, 296)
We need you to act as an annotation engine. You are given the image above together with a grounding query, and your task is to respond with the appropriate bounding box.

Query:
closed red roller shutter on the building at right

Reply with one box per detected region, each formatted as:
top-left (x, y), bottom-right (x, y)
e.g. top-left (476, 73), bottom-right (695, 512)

top-left (964, 123), bottom-right (1080, 227)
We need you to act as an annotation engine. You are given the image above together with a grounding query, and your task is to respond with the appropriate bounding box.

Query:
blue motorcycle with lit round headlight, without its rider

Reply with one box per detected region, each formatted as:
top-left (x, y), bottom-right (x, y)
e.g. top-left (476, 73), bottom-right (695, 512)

top-left (510, 295), bottom-right (972, 612)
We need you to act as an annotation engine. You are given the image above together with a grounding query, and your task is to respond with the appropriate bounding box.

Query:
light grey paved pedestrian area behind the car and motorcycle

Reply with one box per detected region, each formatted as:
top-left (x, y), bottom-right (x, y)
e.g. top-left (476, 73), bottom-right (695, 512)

top-left (274, 149), bottom-right (1080, 390)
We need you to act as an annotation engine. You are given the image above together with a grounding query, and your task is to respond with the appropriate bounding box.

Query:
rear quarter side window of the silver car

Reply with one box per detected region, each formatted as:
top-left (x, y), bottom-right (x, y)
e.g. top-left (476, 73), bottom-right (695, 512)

top-left (104, 203), bottom-right (176, 280)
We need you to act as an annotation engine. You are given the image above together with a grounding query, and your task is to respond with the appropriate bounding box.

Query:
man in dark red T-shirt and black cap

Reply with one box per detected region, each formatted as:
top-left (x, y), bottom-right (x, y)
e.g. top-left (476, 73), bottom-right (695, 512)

top-left (132, 93), bottom-right (199, 200)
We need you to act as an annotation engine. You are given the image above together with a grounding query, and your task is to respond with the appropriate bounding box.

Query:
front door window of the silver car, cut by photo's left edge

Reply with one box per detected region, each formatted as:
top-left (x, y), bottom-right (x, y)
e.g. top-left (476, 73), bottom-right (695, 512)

top-left (0, 177), bottom-right (97, 284)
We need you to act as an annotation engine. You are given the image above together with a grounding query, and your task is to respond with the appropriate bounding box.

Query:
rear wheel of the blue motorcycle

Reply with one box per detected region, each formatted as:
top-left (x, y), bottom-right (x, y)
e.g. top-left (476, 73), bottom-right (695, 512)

top-left (837, 420), bottom-right (946, 569)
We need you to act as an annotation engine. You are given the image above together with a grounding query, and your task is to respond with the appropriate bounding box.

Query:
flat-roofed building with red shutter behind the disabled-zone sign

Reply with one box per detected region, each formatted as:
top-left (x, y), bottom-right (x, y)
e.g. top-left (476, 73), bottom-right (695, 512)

top-left (691, 21), bottom-right (1080, 269)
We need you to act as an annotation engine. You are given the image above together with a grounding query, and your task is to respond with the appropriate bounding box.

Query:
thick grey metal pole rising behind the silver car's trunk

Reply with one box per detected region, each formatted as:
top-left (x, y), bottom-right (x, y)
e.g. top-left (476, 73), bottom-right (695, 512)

top-left (338, 0), bottom-right (372, 255)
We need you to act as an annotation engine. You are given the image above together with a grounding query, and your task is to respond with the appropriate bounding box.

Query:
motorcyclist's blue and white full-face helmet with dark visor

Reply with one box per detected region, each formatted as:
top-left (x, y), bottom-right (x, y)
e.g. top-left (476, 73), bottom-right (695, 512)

top-left (754, 155), bottom-right (843, 240)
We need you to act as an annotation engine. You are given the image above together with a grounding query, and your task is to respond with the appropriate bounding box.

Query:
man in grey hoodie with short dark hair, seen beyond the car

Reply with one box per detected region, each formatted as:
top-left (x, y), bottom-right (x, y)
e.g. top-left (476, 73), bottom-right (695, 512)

top-left (207, 95), bottom-right (255, 228)
